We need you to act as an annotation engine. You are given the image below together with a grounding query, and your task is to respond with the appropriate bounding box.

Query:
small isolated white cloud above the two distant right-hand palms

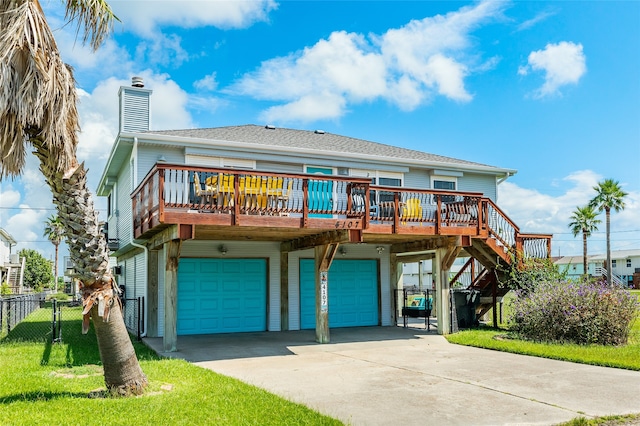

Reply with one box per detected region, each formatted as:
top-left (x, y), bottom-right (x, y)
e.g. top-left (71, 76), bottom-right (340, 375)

top-left (518, 41), bottom-right (587, 99)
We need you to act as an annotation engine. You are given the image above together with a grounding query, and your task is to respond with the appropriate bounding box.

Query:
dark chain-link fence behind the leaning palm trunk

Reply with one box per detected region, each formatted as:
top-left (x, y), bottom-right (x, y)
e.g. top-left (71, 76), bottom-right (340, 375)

top-left (0, 293), bottom-right (144, 344)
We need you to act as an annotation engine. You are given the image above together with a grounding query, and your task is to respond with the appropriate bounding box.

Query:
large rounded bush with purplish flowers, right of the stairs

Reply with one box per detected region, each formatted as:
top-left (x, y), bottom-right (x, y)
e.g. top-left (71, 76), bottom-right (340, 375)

top-left (509, 281), bottom-right (639, 345)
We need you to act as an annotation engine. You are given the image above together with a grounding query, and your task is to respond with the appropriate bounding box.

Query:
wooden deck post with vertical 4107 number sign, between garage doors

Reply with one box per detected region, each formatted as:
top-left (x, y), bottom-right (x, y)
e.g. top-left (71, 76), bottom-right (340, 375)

top-left (314, 243), bottom-right (340, 343)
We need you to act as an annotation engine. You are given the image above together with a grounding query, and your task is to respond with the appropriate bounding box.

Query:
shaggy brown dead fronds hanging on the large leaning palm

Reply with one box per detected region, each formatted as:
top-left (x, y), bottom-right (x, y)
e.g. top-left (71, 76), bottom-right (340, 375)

top-left (0, 0), bottom-right (80, 180)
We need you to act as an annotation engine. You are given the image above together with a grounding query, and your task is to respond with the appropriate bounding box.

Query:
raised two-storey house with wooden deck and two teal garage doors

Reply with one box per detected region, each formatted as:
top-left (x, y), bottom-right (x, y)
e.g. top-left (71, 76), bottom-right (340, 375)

top-left (97, 78), bottom-right (551, 351)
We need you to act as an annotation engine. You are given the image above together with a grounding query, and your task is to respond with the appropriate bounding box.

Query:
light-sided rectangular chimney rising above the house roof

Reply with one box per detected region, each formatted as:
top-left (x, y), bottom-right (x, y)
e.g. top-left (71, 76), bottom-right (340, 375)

top-left (118, 77), bottom-right (153, 133)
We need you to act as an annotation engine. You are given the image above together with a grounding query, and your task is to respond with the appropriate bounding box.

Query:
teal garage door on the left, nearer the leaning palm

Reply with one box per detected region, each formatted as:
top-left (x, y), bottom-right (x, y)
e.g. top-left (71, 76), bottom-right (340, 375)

top-left (177, 258), bottom-right (267, 335)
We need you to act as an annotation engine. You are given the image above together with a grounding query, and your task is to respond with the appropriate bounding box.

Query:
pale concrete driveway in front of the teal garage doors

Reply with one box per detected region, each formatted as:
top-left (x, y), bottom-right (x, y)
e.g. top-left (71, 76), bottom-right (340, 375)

top-left (145, 327), bottom-right (640, 425)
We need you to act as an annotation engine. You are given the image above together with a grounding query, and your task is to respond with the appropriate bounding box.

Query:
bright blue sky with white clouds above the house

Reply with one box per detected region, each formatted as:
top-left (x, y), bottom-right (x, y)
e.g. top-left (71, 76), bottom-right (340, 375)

top-left (0, 0), bottom-right (640, 272)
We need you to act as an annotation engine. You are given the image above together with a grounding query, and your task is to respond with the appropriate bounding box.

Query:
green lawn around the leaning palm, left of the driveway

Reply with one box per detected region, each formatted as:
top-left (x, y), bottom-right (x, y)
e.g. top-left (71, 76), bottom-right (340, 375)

top-left (0, 308), bottom-right (342, 425)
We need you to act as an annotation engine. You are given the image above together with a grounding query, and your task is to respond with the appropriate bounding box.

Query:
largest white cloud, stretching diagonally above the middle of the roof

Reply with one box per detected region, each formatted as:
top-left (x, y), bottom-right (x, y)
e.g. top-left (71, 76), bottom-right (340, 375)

top-left (228, 2), bottom-right (505, 122)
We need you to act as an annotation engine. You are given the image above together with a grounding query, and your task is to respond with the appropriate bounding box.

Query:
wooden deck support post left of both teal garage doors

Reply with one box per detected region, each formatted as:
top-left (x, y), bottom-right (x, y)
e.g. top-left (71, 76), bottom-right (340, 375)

top-left (162, 239), bottom-right (182, 352)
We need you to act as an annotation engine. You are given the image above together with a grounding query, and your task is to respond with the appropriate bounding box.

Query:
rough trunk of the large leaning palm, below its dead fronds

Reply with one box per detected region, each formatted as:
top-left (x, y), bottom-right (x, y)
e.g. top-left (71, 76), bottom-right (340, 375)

top-left (31, 136), bottom-right (147, 394)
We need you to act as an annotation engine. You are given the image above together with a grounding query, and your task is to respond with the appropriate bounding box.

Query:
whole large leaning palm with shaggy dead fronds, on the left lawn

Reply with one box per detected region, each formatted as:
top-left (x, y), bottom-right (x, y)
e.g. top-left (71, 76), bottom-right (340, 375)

top-left (0, 0), bottom-right (147, 394)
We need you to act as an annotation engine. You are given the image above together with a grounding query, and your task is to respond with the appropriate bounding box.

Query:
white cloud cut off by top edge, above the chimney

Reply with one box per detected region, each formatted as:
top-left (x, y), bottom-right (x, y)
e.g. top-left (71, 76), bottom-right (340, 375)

top-left (109, 0), bottom-right (277, 38)
